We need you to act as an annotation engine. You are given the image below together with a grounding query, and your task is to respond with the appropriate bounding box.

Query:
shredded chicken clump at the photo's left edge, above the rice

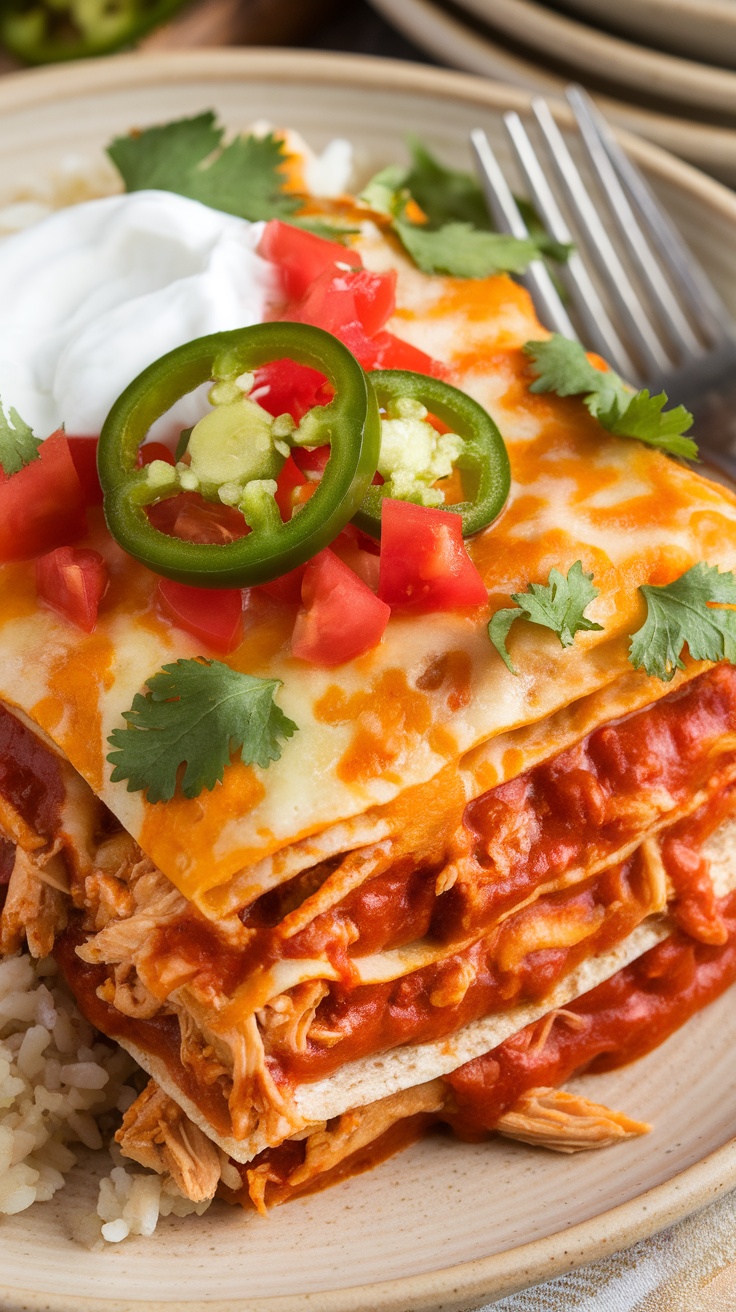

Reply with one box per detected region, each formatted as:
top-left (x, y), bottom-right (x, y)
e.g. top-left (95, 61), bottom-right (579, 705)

top-left (0, 848), bottom-right (68, 958)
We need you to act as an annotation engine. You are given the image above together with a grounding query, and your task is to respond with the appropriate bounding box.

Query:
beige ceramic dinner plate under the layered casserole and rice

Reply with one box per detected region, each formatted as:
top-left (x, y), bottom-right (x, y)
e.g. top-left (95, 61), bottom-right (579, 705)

top-left (0, 51), bottom-right (736, 1312)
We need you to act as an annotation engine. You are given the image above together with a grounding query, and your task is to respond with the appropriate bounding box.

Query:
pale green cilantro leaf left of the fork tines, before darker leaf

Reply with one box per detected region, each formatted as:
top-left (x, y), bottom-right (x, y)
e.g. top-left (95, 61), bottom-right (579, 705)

top-left (394, 219), bottom-right (539, 278)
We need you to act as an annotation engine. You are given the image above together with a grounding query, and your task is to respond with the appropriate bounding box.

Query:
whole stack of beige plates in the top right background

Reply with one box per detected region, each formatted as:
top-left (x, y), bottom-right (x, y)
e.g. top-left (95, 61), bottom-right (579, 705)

top-left (371, 0), bottom-right (736, 185)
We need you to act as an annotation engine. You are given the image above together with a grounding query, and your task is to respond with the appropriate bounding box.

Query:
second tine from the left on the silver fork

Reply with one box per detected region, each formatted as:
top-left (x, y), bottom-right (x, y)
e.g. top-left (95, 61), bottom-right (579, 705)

top-left (504, 113), bottom-right (638, 378)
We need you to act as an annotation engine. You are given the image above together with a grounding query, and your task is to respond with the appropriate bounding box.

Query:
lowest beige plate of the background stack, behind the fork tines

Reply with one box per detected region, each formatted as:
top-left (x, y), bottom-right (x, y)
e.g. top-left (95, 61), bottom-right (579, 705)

top-left (371, 0), bottom-right (736, 186)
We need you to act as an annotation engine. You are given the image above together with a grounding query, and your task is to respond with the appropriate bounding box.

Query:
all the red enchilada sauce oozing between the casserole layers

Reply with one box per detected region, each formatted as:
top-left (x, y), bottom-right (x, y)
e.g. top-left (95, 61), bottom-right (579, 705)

top-left (0, 666), bottom-right (736, 1159)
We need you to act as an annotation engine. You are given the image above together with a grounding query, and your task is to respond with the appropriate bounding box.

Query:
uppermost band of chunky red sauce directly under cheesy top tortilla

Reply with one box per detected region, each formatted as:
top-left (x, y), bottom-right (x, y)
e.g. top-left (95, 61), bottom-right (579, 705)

top-left (236, 665), bottom-right (736, 983)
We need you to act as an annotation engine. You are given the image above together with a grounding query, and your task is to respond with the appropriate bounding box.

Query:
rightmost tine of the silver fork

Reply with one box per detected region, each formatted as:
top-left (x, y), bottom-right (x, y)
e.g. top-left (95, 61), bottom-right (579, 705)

top-left (573, 87), bottom-right (733, 354)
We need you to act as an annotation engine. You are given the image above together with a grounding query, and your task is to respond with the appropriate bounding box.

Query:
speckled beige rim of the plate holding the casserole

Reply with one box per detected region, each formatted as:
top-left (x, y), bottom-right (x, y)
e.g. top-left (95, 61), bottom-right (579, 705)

top-left (0, 50), bottom-right (736, 1312)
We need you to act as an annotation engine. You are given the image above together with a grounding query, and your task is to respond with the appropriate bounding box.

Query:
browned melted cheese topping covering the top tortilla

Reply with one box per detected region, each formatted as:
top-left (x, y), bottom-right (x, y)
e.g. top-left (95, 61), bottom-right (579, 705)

top-left (0, 235), bottom-right (736, 918)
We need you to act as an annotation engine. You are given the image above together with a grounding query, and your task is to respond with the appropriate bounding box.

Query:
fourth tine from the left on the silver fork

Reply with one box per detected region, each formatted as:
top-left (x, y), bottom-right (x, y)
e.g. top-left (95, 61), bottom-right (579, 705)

top-left (567, 87), bottom-right (703, 367)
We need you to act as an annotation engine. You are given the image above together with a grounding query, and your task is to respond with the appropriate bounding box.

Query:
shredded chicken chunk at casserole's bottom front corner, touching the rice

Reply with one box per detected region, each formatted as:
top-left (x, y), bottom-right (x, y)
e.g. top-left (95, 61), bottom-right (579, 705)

top-left (115, 1080), bottom-right (222, 1203)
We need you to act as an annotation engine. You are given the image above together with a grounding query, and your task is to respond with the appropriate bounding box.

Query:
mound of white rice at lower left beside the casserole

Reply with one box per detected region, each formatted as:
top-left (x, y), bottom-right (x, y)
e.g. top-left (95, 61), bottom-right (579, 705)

top-left (0, 955), bottom-right (209, 1246)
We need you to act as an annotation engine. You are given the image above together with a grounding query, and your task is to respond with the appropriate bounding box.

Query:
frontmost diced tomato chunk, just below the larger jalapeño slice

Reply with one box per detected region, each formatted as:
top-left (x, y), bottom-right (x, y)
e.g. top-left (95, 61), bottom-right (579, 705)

top-left (291, 548), bottom-right (391, 665)
